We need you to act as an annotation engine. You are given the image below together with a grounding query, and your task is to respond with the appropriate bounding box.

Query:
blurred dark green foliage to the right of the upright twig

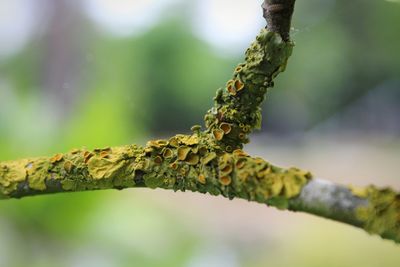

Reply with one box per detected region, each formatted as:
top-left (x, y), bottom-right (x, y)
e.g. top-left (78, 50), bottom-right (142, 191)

top-left (263, 0), bottom-right (400, 136)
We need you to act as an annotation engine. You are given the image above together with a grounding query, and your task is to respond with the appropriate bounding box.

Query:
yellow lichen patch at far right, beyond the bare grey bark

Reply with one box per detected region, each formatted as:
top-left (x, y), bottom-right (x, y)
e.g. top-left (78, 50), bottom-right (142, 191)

top-left (352, 186), bottom-right (400, 243)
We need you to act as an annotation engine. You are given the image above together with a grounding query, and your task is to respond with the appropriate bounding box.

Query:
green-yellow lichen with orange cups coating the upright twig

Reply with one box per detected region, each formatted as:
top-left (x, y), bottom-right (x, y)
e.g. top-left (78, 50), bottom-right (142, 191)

top-left (205, 29), bottom-right (293, 152)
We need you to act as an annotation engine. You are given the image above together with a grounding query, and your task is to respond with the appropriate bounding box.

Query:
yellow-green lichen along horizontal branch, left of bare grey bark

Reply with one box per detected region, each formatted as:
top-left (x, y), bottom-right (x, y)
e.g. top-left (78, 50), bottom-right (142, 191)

top-left (0, 131), bottom-right (311, 208)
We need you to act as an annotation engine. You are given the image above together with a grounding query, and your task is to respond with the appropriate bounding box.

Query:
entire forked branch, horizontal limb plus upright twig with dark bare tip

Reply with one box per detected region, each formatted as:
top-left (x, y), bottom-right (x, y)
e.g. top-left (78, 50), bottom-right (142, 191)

top-left (0, 0), bottom-right (400, 245)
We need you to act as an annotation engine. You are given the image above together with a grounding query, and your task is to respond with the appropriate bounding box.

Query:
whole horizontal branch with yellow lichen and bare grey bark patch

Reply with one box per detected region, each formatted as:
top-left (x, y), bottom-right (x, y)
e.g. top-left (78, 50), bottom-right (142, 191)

top-left (0, 136), bottom-right (400, 245)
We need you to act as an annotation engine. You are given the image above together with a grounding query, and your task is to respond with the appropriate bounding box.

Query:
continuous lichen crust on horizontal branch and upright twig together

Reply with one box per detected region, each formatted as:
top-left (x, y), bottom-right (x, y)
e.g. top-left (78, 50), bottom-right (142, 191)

top-left (0, 29), bottom-right (304, 205)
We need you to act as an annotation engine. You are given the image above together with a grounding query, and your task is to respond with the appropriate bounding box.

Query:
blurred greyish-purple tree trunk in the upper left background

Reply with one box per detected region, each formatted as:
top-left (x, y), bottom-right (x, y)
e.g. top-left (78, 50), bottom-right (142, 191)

top-left (41, 0), bottom-right (83, 122)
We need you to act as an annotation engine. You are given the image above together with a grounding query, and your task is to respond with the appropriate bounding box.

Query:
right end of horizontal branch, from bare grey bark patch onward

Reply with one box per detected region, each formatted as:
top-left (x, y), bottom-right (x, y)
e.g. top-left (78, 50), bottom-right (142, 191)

top-left (289, 179), bottom-right (400, 243)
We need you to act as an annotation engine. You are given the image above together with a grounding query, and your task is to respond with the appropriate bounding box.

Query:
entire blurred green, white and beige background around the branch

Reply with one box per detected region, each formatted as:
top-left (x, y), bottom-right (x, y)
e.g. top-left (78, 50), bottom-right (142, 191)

top-left (0, 0), bottom-right (400, 267)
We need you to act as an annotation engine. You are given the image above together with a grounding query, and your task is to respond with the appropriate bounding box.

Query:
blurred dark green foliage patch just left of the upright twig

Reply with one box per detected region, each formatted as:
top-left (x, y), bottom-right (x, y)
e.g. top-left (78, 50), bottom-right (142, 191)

top-left (135, 19), bottom-right (235, 133)
